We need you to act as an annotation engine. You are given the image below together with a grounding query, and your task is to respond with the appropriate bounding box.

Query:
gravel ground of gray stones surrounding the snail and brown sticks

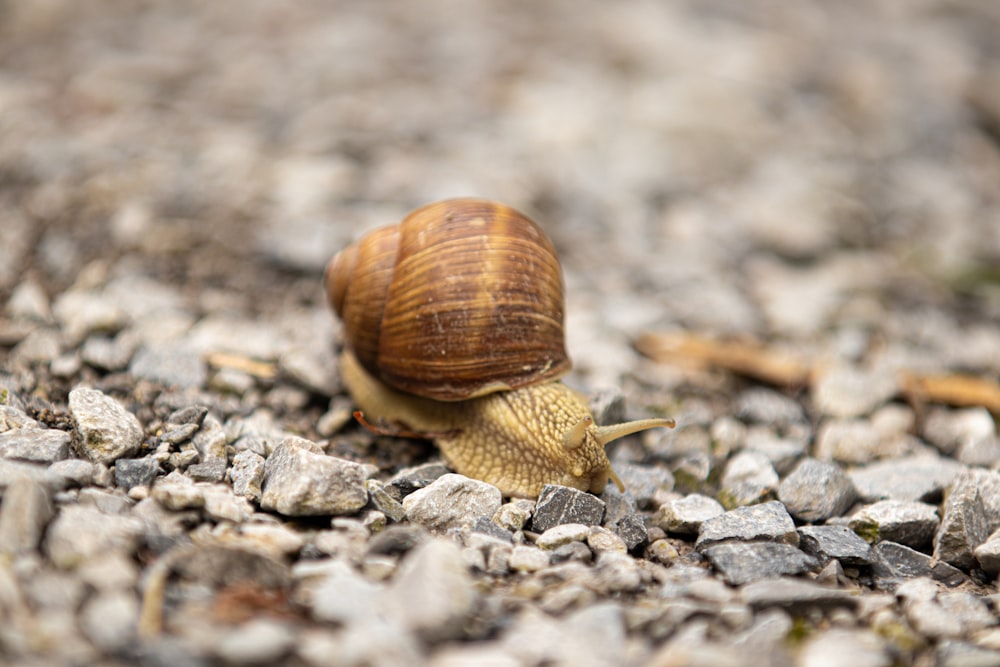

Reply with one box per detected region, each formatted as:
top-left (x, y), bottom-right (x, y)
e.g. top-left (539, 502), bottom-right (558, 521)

top-left (0, 0), bottom-right (1000, 667)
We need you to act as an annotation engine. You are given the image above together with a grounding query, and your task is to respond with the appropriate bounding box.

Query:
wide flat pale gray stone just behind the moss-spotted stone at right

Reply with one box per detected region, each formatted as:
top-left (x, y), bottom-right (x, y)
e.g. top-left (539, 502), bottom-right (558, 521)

top-left (847, 455), bottom-right (965, 502)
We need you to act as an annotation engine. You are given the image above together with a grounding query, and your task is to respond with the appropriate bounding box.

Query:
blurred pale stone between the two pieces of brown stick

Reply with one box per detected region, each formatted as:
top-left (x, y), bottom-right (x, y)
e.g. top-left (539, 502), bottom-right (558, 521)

top-left (811, 365), bottom-right (898, 418)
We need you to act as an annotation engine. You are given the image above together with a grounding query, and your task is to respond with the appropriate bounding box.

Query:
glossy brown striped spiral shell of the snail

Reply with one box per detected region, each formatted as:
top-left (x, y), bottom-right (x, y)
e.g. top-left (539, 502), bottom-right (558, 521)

top-left (326, 199), bottom-right (570, 401)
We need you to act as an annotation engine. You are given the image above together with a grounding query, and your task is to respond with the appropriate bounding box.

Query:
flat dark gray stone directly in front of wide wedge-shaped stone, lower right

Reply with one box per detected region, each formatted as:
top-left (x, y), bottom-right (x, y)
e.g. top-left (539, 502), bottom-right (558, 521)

top-left (702, 542), bottom-right (818, 586)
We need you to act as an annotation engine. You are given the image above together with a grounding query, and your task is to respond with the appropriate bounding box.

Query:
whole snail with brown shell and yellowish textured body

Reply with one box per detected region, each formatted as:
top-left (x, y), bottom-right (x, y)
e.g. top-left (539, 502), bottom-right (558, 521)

top-left (324, 199), bottom-right (674, 497)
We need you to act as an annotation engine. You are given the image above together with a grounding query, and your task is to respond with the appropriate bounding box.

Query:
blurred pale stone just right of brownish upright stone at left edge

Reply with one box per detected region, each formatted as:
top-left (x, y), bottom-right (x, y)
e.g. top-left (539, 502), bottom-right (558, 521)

top-left (44, 505), bottom-right (143, 569)
